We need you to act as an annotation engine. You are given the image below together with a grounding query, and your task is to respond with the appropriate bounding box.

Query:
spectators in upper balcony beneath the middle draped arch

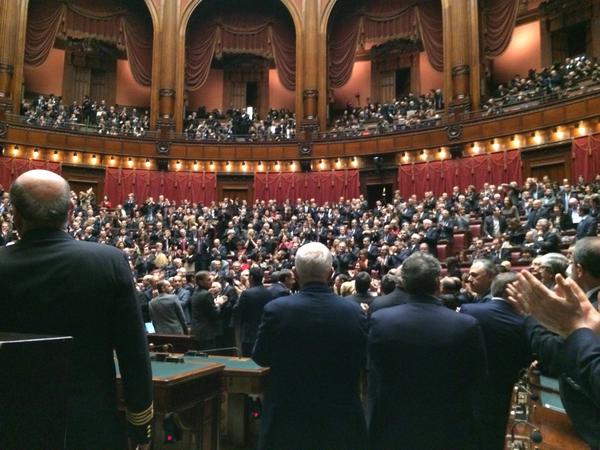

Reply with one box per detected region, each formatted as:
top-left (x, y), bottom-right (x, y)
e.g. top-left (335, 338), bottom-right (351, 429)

top-left (184, 107), bottom-right (296, 141)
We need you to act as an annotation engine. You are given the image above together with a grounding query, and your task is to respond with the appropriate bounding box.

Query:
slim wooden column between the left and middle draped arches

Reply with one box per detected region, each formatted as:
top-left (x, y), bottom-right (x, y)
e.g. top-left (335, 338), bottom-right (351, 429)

top-left (152, 1), bottom-right (179, 136)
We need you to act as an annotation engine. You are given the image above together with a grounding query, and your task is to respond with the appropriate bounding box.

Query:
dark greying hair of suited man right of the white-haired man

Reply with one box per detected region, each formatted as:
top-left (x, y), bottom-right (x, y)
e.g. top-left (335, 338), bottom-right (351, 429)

top-left (400, 252), bottom-right (442, 295)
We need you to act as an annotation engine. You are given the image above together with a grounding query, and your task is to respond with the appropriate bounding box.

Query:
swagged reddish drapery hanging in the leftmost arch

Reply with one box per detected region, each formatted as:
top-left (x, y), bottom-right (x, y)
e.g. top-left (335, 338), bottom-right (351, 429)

top-left (25, 0), bottom-right (153, 86)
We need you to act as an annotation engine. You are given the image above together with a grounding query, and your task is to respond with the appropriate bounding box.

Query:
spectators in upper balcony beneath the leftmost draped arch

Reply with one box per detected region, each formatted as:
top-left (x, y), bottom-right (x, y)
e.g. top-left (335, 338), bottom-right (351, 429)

top-left (21, 94), bottom-right (150, 137)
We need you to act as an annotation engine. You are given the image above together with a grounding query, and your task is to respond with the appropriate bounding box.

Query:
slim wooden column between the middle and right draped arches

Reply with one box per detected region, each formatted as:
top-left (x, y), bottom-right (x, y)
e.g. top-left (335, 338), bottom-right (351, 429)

top-left (296, 0), bottom-right (319, 140)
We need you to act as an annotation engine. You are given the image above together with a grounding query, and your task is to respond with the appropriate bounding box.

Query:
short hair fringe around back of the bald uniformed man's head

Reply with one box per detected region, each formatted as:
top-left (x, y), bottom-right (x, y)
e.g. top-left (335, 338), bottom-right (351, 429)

top-left (10, 172), bottom-right (71, 229)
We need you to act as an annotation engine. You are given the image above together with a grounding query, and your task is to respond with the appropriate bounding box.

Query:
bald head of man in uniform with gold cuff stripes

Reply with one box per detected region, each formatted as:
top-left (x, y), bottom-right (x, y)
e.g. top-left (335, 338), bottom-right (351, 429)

top-left (10, 170), bottom-right (71, 234)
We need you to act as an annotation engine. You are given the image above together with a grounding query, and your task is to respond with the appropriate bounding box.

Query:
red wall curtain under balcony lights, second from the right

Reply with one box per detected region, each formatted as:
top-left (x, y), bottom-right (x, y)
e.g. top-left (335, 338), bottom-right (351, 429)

top-left (398, 150), bottom-right (522, 198)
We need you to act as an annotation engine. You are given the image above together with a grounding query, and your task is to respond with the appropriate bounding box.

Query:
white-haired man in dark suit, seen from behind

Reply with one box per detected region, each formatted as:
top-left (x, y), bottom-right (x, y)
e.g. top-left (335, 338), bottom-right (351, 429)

top-left (253, 242), bottom-right (366, 450)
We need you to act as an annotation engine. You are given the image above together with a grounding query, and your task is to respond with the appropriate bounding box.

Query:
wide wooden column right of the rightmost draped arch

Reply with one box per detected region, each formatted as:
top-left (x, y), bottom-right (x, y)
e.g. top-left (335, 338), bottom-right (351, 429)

top-left (442, 0), bottom-right (481, 112)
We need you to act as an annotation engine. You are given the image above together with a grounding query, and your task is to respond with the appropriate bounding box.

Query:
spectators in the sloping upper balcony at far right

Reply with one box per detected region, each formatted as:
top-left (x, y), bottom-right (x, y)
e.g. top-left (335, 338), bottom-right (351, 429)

top-left (483, 56), bottom-right (600, 115)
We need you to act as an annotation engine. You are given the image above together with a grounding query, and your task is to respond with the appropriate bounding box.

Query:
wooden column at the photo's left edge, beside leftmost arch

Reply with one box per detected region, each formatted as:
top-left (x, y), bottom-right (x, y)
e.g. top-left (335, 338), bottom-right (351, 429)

top-left (0, 0), bottom-right (28, 113)
